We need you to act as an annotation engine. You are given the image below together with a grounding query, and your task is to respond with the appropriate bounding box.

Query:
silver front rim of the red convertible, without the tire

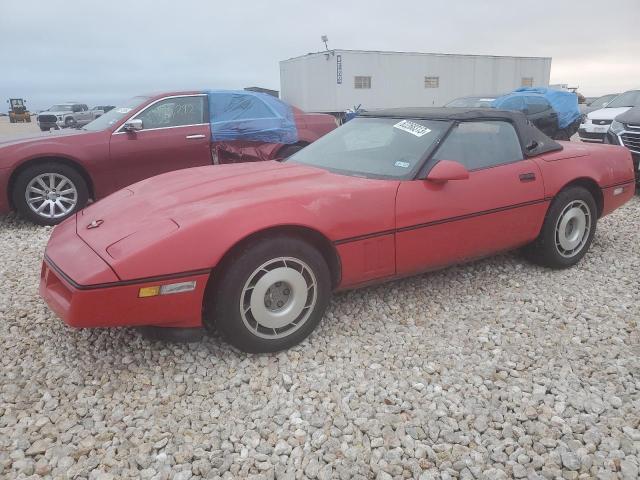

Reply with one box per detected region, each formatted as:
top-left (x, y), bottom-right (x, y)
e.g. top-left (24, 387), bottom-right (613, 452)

top-left (240, 257), bottom-right (318, 339)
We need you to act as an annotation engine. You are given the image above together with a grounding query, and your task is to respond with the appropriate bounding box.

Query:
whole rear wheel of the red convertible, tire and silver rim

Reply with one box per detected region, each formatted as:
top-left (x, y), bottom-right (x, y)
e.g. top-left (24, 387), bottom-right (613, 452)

top-left (525, 186), bottom-right (598, 268)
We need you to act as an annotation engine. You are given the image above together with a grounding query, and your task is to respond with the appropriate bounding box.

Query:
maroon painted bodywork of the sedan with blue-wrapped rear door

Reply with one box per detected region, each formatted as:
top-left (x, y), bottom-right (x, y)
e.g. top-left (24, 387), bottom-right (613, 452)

top-left (0, 91), bottom-right (336, 214)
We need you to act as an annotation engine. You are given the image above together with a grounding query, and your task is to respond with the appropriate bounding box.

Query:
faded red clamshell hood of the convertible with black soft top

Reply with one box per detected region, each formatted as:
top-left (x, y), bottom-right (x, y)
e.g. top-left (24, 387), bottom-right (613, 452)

top-left (77, 161), bottom-right (398, 278)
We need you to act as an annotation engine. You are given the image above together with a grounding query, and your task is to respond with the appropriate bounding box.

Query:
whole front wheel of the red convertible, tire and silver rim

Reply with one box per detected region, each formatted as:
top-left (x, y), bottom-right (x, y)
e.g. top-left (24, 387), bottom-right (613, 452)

top-left (204, 235), bottom-right (331, 353)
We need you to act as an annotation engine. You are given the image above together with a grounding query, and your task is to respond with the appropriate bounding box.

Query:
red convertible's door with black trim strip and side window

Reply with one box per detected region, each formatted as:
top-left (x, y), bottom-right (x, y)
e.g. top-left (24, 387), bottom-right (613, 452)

top-left (396, 121), bottom-right (546, 275)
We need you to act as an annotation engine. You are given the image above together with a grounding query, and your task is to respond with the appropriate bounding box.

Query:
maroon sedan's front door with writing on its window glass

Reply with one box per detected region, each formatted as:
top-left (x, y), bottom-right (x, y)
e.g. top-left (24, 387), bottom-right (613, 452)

top-left (105, 95), bottom-right (211, 189)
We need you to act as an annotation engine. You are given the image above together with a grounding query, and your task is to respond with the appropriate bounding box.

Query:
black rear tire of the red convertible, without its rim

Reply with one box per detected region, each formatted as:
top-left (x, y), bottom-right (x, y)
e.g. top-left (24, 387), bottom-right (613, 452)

top-left (524, 186), bottom-right (598, 268)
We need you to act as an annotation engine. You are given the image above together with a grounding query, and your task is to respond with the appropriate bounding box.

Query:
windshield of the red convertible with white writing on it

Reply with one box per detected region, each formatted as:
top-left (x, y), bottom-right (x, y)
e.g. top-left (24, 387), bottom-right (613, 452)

top-left (288, 117), bottom-right (450, 179)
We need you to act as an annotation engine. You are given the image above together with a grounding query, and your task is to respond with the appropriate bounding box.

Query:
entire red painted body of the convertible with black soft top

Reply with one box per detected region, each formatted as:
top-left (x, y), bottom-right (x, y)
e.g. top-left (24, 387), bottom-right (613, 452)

top-left (40, 138), bottom-right (634, 327)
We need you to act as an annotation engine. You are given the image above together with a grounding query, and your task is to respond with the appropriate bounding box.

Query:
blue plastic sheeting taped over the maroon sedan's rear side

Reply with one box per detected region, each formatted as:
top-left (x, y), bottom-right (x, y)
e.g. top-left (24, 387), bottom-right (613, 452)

top-left (206, 90), bottom-right (298, 144)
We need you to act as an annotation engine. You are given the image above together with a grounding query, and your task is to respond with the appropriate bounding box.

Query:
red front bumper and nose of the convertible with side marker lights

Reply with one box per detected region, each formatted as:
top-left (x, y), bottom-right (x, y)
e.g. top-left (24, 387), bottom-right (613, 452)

top-left (39, 218), bottom-right (209, 328)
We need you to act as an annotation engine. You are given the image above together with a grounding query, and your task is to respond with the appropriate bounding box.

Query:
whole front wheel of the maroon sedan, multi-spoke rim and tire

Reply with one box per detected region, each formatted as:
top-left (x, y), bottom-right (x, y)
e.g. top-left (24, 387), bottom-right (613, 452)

top-left (13, 163), bottom-right (89, 225)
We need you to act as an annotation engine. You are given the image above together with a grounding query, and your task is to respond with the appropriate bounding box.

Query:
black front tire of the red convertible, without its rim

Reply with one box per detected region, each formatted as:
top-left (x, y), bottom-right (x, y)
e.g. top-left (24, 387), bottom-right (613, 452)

top-left (203, 235), bottom-right (331, 353)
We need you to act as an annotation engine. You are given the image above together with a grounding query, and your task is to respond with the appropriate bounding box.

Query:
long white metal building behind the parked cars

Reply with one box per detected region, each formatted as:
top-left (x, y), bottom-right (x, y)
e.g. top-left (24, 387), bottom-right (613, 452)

top-left (280, 50), bottom-right (551, 112)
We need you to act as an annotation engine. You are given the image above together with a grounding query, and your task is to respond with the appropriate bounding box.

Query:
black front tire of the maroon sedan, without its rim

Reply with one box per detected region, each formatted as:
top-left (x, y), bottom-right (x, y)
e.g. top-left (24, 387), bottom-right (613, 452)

top-left (12, 162), bottom-right (89, 225)
